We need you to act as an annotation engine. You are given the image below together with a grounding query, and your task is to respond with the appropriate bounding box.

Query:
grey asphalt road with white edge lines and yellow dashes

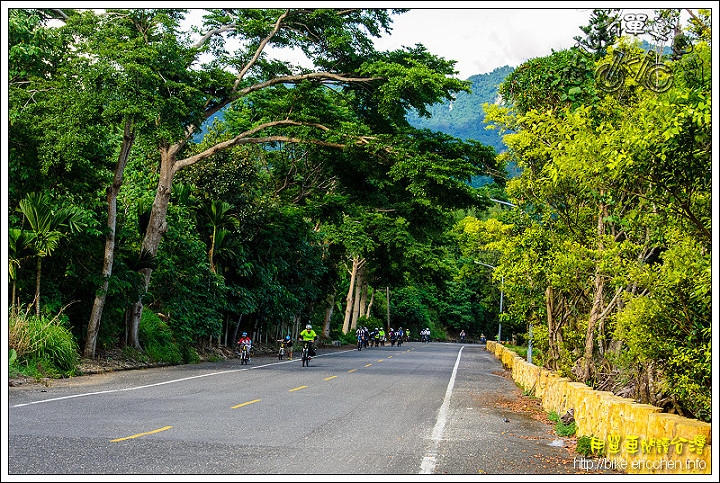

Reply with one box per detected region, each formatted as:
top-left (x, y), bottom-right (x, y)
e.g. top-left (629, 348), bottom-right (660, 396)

top-left (3, 342), bottom-right (620, 481)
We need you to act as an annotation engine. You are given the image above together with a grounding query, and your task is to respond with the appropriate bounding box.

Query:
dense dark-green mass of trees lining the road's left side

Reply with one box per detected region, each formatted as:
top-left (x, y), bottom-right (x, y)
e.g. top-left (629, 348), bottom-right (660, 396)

top-left (8, 9), bottom-right (505, 372)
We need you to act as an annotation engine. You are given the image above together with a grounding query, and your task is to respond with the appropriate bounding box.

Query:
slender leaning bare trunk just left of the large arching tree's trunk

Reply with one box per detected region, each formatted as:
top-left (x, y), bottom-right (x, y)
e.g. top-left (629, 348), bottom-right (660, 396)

top-left (83, 121), bottom-right (135, 358)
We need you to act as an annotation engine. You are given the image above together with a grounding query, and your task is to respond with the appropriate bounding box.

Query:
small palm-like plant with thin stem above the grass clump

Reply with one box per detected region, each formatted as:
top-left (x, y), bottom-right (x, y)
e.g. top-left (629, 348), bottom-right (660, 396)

top-left (18, 193), bottom-right (83, 317)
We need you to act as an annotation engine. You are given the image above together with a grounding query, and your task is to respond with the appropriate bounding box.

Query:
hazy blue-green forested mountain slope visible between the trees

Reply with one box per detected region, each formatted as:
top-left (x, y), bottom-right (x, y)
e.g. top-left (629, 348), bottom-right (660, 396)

top-left (407, 65), bottom-right (514, 152)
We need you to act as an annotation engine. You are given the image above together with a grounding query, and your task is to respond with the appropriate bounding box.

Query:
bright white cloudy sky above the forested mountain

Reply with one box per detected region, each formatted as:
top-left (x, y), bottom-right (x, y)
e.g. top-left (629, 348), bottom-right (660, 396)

top-left (177, 0), bottom-right (714, 79)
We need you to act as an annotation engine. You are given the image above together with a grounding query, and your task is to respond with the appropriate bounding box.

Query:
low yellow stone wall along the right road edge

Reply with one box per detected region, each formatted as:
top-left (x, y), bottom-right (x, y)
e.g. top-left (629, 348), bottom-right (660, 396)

top-left (486, 341), bottom-right (712, 474)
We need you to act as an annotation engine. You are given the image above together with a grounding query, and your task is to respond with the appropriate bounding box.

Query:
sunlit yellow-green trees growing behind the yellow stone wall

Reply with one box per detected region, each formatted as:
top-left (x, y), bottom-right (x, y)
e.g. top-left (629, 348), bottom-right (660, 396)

top-left (486, 11), bottom-right (711, 420)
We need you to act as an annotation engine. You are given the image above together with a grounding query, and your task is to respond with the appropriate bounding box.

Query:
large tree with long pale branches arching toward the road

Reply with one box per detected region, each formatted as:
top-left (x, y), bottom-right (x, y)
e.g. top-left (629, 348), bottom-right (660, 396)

top-left (87, 9), bottom-right (467, 347)
